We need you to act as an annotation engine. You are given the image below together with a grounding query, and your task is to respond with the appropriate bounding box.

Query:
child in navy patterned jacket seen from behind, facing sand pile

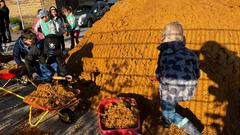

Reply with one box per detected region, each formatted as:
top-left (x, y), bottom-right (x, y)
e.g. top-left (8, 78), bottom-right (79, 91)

top-left (153, 22), bottom-right (201, 135)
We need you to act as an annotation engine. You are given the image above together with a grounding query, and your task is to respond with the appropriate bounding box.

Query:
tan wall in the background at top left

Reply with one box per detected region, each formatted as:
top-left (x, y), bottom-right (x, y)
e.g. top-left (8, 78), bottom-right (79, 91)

top-left (6, 0), bottom-right (56, 27)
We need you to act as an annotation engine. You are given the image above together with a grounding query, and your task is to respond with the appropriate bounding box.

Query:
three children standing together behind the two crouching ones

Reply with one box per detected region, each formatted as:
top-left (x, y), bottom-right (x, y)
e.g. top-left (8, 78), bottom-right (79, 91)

top-left (32, 6), bottom-right (80, 51)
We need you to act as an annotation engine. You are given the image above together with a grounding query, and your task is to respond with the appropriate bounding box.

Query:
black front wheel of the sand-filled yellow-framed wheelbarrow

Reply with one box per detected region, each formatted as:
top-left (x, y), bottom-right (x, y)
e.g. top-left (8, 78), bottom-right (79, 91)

top-left (58, 108), bottom-right (74, 124)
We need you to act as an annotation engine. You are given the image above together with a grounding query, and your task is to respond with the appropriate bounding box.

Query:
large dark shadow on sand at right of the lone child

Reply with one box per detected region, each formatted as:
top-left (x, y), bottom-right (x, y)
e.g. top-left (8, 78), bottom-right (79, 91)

top-left (200, 41), bottom-right (240, 135)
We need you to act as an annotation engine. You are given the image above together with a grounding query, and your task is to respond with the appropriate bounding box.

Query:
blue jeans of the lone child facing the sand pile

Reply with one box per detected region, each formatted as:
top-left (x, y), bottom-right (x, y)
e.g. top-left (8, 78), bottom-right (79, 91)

top-left (160, 99), bottom-right (184, 125)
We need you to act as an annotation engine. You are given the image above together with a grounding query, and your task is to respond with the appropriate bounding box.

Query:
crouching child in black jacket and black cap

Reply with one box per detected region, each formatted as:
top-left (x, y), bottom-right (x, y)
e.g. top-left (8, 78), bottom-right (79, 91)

top-left (26, 35), bottom-right (71, 82)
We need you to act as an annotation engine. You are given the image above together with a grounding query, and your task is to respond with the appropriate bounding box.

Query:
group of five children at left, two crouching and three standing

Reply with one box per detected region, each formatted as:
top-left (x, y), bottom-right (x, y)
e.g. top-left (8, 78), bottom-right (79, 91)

top-left (13, 6), bottom-right (80, 82)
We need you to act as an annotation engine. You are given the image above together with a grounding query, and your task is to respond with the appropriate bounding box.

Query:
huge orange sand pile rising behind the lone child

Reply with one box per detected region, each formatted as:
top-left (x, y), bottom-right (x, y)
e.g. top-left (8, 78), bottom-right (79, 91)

top-left (67, 0), bottom-right (240, 135)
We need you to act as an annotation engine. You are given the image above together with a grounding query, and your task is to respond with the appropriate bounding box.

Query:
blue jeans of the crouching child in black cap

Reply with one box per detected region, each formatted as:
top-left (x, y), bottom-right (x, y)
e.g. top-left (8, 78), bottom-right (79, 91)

top-left (36, 62), bottom-right (59, 82)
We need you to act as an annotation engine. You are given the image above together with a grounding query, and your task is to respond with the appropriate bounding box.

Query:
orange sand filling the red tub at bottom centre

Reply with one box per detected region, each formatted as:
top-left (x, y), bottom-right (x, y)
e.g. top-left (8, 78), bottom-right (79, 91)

top-left (101, 100), bottom-right (139, 129)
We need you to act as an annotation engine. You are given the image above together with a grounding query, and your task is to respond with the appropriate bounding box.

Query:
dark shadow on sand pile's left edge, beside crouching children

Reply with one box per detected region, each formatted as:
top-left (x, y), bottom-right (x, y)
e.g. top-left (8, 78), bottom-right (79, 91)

top-left (67, 42), bottom-right (93, 77)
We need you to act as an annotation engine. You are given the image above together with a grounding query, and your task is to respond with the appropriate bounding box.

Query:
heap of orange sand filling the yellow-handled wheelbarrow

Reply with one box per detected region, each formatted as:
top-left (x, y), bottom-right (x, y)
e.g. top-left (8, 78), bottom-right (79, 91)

top-left (24, 84), bottom-right (77, 110)
